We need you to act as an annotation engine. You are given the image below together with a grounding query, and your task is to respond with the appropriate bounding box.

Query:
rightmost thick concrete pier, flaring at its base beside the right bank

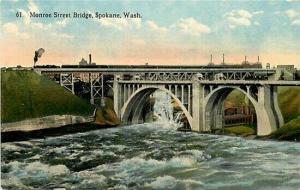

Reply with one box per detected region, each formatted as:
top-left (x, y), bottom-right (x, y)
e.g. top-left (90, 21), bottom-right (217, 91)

top-left (256, 85), bottom-right (283, 136)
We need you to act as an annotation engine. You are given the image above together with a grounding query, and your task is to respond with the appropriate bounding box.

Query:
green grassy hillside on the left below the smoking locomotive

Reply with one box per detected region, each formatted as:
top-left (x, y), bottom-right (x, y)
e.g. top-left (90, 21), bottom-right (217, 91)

top-left (1, 71), bottom-right (94, 123)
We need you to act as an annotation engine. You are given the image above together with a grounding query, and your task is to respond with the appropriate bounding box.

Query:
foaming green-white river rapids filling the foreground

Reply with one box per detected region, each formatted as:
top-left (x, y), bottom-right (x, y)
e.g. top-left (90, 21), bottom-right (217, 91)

top-left (1, 123), bottom-right (300, 190)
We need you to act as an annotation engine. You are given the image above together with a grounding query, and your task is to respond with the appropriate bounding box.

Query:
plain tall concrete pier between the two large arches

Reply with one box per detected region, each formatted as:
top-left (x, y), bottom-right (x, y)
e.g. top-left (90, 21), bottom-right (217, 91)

top-left (191, 80), bottom-right (206, 131)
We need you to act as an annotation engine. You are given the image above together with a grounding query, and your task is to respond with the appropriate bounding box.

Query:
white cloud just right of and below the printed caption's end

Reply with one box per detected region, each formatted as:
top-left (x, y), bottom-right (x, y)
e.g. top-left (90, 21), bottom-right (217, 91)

top-left (173, 17), bottom-right (211, 36)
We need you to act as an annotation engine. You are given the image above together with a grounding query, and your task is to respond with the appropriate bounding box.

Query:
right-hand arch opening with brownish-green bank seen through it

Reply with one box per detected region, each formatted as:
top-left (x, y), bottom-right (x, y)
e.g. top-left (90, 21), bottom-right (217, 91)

top-left (205, 87), bottom-right (257, 135)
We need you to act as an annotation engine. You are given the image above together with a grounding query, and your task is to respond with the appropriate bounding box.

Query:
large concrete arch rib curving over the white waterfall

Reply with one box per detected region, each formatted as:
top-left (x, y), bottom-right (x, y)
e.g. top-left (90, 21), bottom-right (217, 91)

top-left (121, 85), bottom-right (192, 127)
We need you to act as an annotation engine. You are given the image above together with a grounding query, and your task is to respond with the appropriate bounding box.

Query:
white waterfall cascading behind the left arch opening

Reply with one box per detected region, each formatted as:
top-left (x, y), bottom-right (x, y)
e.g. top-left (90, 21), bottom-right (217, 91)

top-left (153, 90), bottom-right (183, 129)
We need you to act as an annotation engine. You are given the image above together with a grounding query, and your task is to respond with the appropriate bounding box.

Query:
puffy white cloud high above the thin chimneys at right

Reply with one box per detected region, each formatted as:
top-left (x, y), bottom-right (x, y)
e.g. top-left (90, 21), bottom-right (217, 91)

top-left (225, 9), bottom-right (253, 28)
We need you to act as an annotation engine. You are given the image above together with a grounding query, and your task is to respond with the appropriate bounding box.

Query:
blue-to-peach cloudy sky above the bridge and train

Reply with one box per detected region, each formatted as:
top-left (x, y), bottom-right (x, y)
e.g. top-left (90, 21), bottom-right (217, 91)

top-left (0, 0), bottom-right (300, 68)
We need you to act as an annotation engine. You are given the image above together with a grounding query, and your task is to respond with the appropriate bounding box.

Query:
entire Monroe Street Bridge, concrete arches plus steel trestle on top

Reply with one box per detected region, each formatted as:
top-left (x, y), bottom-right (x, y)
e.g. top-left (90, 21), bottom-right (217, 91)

top-left (34, 65), bottom-right (300, 135)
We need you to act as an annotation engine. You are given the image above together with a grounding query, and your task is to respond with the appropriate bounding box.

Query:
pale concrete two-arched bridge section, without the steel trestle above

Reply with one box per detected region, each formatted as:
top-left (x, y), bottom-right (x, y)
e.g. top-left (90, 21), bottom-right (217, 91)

top-left (114, 80), bottom-right (298, 135)
